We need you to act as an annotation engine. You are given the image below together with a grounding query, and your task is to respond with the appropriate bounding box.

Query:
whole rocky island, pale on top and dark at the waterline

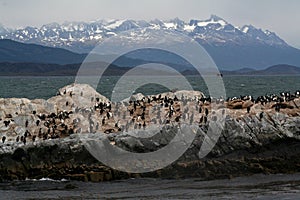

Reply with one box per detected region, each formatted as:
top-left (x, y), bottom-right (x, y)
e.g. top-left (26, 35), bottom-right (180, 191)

top-left (0, 84), bottom-right (300, 181)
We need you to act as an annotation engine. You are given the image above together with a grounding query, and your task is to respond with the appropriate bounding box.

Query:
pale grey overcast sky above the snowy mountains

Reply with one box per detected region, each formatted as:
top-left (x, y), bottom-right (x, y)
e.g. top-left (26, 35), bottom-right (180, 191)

top-left (0, 0), bottom-right (300, 48)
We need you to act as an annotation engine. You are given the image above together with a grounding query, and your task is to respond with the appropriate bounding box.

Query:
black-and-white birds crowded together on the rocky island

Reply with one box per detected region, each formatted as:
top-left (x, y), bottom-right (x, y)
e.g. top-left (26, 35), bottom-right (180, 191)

top-left (0, 88), bottom-right (300, 144)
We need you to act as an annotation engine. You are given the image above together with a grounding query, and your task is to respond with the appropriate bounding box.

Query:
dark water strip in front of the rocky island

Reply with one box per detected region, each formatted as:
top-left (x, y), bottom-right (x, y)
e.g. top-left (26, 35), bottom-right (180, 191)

top-left (0, 174), bottom-right (300, 200)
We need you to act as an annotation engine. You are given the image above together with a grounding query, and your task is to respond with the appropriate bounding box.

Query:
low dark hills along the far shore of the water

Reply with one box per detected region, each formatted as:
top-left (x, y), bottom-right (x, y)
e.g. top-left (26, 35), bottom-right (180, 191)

top-left (0, 62), bottom-right (300, 77)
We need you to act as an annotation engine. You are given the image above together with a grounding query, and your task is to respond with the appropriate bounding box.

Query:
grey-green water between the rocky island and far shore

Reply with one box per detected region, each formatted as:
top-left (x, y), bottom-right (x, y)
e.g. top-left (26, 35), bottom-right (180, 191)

top-left (0, 76), bottom-right (300, 99)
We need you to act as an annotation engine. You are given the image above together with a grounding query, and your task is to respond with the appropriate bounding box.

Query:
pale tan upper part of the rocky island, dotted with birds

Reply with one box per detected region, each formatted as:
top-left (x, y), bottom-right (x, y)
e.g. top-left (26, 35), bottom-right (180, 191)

top-left (0, 86), bottom-right (300, 145)
